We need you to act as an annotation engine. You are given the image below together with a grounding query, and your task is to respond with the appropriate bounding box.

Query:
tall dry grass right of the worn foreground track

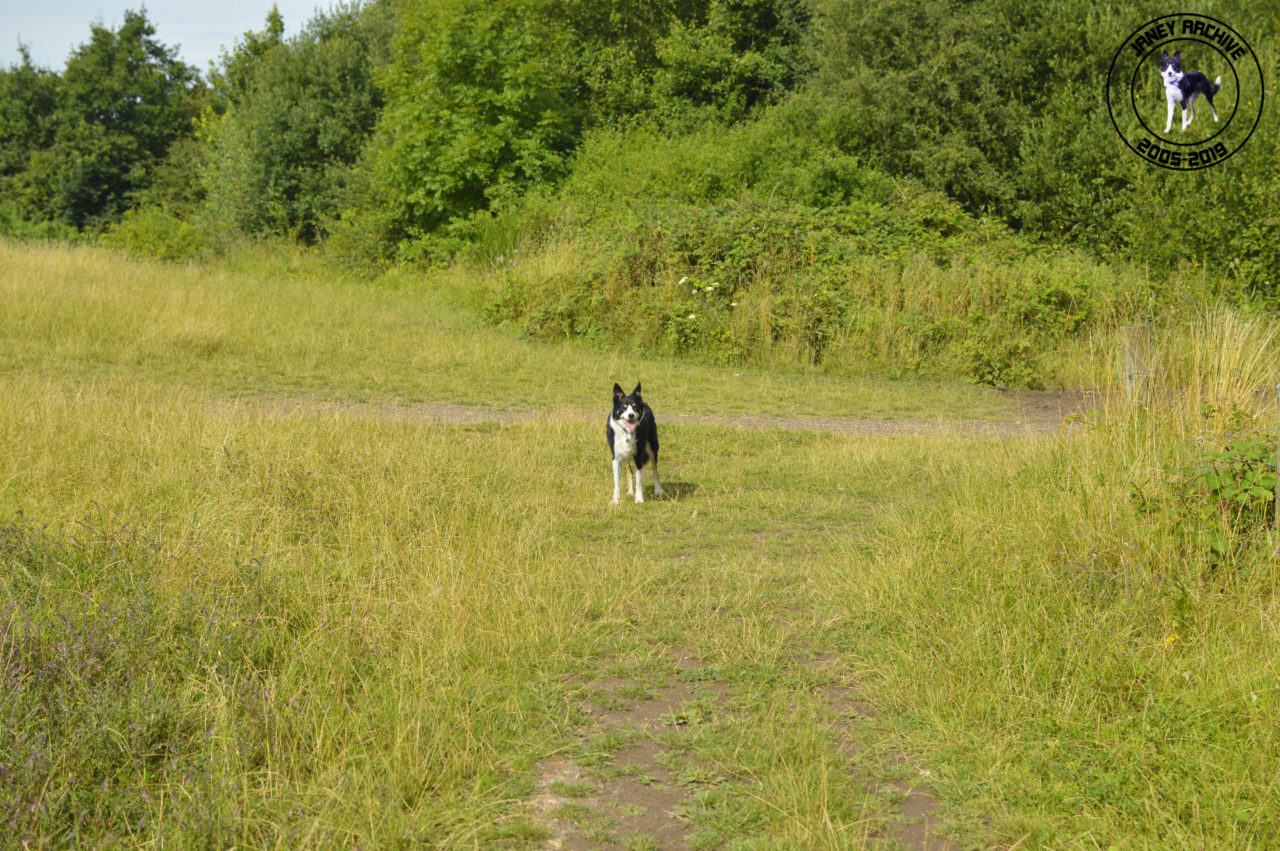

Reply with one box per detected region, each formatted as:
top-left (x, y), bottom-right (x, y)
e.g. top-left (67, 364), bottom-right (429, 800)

top-left (836, 298), bottom-right (1280, 847)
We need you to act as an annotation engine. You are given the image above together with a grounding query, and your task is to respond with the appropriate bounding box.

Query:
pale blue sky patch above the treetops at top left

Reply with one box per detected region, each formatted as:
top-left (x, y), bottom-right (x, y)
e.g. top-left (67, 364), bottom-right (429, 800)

top-left (0, 0), bottom-right (330, 74)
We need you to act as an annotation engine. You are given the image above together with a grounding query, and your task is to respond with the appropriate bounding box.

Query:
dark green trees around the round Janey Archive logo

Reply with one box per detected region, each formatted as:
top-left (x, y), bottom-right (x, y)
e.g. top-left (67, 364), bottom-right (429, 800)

top-left (788, 0), bottom-right (1280, 296)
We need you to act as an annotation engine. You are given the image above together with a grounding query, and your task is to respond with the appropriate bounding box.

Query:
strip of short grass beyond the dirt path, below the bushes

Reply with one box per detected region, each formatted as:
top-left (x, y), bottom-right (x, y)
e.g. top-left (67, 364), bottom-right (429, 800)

top-left (0, 244), bottom-right (1015, 420)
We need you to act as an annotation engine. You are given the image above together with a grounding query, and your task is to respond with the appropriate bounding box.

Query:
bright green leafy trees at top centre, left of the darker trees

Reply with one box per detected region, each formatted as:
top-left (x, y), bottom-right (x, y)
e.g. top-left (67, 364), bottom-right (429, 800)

top-left (372, 0), bottom-right (808, 249)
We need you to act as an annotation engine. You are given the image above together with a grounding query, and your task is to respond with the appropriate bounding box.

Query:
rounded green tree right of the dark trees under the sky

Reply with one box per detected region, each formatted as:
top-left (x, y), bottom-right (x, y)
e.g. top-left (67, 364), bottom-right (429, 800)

top-left (205, 3), bottom-right (390, 241)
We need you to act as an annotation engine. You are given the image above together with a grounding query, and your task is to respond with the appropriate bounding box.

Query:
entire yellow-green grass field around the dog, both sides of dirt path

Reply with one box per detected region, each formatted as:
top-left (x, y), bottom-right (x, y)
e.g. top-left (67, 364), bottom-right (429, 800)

top-left (0, 243), bottom-right (1280, 848)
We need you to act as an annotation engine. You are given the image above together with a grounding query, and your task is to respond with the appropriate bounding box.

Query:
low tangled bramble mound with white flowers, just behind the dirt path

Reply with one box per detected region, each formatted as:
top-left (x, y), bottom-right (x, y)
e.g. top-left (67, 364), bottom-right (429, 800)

top-left (477, 192), bottom-right (1167, 386)
